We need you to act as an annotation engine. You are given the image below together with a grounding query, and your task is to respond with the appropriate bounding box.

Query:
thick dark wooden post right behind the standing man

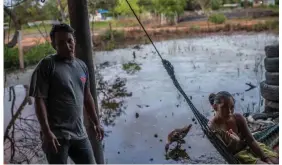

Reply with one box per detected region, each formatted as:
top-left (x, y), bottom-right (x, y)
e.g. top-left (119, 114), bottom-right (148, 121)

top-left (68, 0), bottom-right (104, 164)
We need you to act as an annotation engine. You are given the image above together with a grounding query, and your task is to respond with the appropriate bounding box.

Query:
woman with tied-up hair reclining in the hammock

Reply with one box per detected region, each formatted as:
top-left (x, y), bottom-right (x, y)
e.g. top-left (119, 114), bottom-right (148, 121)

top-left (209, 91), bottom-right (279, 164)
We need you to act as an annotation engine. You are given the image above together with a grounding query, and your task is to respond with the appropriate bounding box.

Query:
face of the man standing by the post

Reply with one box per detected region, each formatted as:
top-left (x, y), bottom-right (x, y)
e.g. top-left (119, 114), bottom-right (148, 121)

top-left (53, 32), bottom-right (75, 59)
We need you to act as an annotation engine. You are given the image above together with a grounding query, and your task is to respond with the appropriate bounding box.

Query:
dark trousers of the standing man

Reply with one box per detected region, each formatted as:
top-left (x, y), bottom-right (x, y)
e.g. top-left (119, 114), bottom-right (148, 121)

top-left (42, 138), bottom-right (96, 164)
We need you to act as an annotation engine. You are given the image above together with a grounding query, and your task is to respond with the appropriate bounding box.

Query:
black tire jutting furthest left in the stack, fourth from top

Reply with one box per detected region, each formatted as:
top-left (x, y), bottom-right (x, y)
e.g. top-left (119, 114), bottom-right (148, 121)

top-left (260, 81), bottom-right (279, 102)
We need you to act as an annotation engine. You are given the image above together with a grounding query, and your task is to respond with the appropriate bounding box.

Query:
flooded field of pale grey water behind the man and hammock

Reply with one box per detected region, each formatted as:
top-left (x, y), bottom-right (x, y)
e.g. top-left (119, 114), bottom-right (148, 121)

top-left (4, 33), bottom-right (278, 164)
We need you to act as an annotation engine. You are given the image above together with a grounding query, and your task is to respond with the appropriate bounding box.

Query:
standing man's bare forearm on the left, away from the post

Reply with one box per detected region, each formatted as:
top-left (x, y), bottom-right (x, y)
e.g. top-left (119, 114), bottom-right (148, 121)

top-left (35, 98), bottom-right (51, 134)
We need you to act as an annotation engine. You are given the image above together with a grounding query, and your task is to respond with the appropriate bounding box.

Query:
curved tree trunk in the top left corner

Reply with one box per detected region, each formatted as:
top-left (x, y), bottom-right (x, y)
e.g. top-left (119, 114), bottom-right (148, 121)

top-left (4, 6), bottom-right (22, 48)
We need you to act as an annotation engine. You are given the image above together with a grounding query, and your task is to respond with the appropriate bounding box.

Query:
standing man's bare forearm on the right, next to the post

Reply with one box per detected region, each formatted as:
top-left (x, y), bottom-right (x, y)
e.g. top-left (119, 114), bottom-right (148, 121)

top-left (84, 87), bottom-right (100, 126)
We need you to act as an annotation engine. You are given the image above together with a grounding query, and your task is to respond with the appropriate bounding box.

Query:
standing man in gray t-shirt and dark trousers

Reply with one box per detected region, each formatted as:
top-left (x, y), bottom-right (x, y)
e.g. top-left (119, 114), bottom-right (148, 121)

top-left (29, 24), bottom-right (104, 164)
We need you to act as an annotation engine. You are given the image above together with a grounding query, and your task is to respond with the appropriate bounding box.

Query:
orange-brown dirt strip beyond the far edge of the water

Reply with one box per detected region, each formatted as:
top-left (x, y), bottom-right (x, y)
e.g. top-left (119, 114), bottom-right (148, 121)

top-left (5, 19), bottom-right (278, 49)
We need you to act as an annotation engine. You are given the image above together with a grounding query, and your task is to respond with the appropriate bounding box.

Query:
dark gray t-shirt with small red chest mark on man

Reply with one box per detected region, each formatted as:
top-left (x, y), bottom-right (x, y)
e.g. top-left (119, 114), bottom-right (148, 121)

top-left (29, 55), bottom-right (89, 140)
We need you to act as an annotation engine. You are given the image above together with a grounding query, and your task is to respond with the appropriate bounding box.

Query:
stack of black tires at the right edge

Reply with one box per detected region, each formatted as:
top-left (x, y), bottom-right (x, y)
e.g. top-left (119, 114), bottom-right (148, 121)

top-left (260, 45), bottom-right (279, 113)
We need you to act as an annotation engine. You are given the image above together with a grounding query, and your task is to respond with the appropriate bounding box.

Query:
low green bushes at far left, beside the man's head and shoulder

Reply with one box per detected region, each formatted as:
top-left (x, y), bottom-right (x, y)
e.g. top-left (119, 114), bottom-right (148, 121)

top-left (4, 42), bottom-right (56, 69)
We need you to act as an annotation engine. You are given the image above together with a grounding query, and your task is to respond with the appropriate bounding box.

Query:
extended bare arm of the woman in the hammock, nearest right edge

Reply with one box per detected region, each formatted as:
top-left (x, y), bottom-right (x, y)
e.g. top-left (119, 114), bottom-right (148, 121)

top-left (234, 114), bottom-right (267, 161)
